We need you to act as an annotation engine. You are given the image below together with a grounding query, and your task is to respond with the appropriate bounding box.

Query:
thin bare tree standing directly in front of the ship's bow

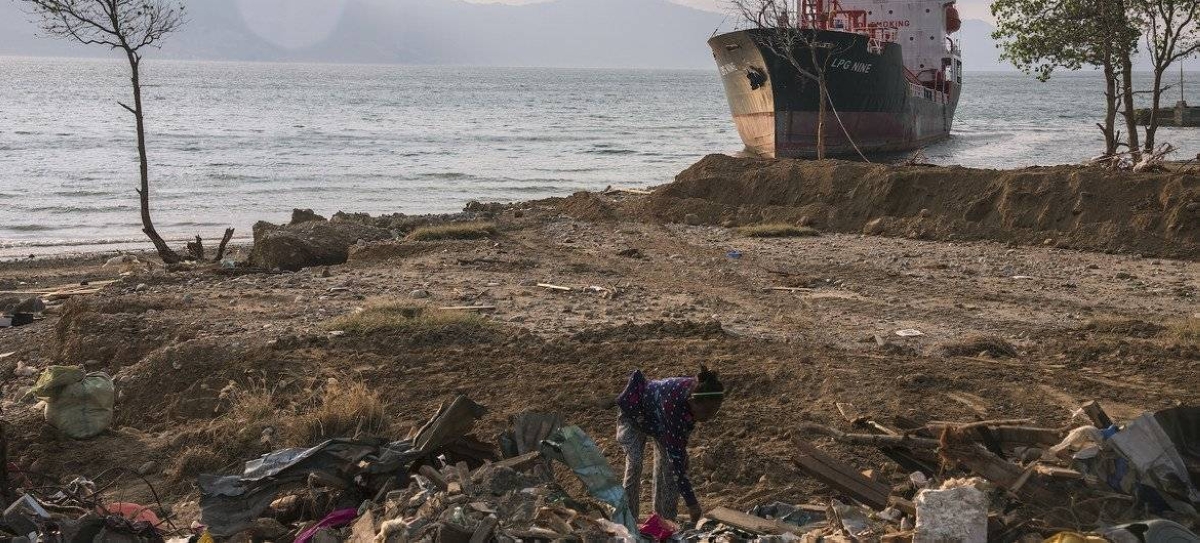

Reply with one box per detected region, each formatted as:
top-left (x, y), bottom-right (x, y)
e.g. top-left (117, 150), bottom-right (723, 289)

top-left (731, 0), bottom-right (848, 160)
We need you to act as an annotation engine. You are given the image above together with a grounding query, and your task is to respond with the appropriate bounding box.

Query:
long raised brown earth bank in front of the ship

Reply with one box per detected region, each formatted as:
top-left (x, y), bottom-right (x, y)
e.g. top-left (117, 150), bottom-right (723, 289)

top-left (641, 155), bottom-right (1200, 259)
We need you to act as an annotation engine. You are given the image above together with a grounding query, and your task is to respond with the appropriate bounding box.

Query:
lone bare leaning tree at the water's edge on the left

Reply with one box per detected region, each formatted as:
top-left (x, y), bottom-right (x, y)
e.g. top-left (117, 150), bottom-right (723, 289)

top-left (18, 0), bottom-right (234, 264)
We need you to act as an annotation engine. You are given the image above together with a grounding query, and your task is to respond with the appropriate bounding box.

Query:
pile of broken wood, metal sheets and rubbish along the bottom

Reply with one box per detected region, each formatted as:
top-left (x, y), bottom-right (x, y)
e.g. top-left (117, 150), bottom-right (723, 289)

top-left (0, 395), bottom-right (1200, 543)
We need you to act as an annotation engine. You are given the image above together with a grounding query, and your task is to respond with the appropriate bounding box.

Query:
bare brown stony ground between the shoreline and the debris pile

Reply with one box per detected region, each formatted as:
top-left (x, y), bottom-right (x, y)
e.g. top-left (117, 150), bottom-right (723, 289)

top-left (0, 194), bottom-right (1200, 524)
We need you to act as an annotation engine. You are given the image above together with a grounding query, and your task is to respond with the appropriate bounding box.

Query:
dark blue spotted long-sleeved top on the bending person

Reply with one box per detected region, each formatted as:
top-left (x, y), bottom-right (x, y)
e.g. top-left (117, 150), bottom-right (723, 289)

top-left (617, 370), bottom-right (698, 506)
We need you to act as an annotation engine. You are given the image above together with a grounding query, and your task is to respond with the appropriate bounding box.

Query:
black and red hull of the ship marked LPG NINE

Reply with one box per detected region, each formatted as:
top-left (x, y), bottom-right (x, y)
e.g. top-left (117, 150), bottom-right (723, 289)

top-left (708, 29), bottom-right (959, 157)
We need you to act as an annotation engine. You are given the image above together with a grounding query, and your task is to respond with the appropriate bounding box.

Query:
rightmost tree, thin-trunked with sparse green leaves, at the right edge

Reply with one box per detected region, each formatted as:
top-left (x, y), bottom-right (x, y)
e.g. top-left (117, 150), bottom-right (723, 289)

top-left (1133, 0), bottom-right (1200, 154)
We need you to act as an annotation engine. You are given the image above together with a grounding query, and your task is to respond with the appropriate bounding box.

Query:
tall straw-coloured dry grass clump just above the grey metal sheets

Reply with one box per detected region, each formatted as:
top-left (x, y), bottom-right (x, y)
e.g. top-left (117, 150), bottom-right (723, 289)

top-left (282, 382), bottom-right (389, 447)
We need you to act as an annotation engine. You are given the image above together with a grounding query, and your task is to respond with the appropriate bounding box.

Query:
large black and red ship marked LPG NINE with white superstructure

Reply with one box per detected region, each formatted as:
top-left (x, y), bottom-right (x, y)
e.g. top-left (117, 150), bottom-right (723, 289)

top-left (708, 0), bottom-right (962, 157)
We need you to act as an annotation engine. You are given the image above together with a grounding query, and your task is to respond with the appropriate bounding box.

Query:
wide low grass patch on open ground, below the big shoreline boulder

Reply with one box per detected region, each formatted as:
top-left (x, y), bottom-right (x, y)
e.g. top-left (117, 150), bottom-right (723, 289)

top-left (325, 303), bottom-right (496, 335)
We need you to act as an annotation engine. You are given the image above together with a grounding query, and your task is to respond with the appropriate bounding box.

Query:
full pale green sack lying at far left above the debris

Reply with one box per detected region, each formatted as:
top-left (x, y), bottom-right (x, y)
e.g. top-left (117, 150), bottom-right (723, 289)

top-left (46, 372), bottom-right (116, 440)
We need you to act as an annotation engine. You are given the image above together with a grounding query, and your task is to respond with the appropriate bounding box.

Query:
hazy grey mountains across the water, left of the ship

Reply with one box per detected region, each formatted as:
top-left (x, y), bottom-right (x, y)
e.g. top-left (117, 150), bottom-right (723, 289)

top-left (0, 0), bottom-right (722, 68)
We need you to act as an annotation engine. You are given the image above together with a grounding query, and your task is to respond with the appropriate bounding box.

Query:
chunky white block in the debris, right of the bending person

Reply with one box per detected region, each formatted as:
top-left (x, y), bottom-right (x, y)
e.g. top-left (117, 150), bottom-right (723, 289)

top-left (912, 478), bottom-right (988, 543)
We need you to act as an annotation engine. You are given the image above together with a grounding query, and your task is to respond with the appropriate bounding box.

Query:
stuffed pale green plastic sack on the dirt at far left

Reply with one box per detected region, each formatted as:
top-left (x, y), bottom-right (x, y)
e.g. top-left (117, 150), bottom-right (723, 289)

top-left (32, 366), bottom-right (116, 440)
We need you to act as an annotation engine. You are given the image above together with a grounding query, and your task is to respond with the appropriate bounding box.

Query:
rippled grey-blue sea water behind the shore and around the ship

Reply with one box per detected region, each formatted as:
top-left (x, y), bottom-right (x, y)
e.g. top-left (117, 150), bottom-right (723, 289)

top-left (0, 58), bottom-right (1200, 257)
